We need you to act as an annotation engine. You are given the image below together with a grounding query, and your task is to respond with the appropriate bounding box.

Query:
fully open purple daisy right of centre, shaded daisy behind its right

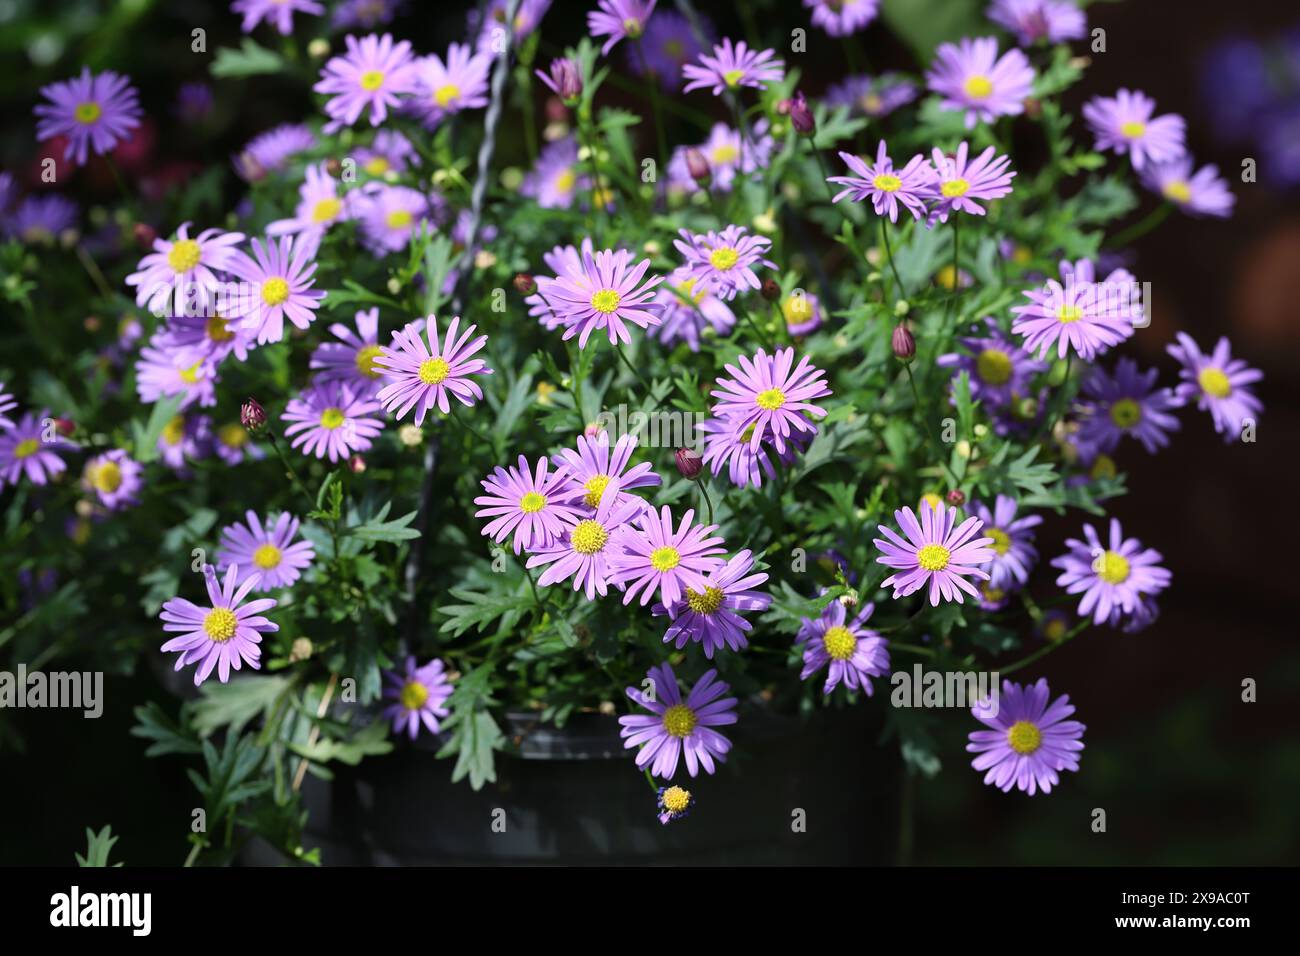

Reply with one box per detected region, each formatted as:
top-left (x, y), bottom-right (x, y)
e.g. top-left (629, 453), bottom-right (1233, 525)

top-left (875, 502), bottom-right (996, 606)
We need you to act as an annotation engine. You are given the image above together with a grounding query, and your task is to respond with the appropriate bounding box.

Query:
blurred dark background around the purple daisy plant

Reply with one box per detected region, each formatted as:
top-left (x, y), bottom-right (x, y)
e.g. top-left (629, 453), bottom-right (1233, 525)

top-left (0, 0), bottom-right (1300, 865)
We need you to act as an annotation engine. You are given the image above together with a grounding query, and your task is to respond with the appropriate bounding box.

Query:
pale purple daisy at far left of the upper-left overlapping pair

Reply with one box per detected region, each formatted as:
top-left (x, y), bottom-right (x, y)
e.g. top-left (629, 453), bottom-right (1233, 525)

top-left (126, 222), bottom-right (244, 315)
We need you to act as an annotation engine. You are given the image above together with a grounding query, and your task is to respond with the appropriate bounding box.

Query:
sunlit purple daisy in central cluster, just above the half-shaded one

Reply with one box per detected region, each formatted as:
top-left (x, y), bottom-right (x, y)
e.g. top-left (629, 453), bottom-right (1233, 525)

top-left (610, 505), bottom-right (723, 607)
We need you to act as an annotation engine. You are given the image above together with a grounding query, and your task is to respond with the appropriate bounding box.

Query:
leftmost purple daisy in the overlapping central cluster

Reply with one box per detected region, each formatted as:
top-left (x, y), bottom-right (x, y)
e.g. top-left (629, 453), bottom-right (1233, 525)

top-left (475, 455), bottom-right (581, 554)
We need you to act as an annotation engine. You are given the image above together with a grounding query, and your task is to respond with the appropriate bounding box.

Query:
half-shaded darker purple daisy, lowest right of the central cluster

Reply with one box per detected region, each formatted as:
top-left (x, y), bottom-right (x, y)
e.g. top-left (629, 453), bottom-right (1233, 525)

top-left (651, 549), bottom-right (772, 661)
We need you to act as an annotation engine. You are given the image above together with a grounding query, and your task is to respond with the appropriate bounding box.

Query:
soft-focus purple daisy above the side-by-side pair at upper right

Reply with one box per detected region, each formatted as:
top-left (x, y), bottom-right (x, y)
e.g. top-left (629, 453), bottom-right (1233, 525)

top-left (926, 36), bottom-right (1034, 129)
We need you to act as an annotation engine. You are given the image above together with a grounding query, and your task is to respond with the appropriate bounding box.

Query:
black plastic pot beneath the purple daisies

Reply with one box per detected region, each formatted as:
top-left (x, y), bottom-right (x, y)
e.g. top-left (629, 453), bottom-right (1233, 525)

top-left (253, 704), bottom-right (901, 866)
